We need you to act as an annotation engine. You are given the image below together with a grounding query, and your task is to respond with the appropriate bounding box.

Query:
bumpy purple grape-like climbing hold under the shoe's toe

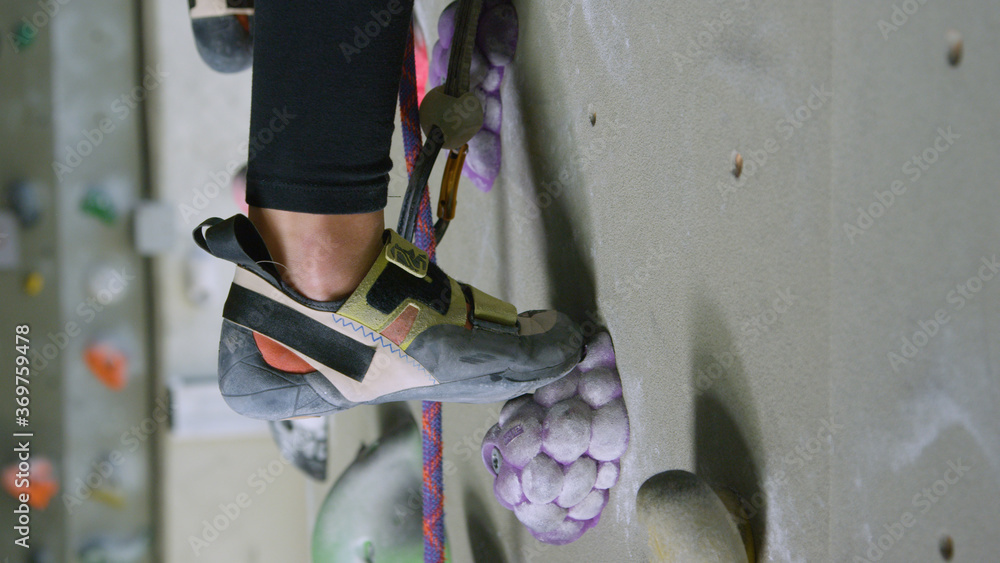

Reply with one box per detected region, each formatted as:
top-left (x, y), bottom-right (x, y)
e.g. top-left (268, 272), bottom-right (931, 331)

top-left (482, 333), bottom-right (629, 545)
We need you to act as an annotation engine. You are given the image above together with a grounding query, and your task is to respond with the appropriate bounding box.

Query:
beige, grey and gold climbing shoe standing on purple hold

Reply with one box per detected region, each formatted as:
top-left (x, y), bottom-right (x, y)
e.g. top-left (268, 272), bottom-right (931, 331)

top-left (194, 215), bottom-right (583, 420)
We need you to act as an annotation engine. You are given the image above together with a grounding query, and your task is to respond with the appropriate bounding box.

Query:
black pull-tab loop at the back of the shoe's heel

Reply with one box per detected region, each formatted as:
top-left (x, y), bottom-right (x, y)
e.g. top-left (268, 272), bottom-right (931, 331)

top-left (193, 215), bottom-right (280, 287)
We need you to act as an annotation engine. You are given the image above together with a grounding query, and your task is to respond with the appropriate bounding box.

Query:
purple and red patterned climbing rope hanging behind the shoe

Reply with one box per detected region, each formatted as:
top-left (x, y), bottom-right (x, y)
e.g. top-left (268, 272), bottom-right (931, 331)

top-left (399, 23), bottom-right (444, 563)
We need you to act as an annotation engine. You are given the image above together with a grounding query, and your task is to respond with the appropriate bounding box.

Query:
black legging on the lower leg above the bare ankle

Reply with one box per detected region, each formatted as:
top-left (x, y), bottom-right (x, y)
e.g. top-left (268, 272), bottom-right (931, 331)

top-left (247, 0), bottom-right (413, 214)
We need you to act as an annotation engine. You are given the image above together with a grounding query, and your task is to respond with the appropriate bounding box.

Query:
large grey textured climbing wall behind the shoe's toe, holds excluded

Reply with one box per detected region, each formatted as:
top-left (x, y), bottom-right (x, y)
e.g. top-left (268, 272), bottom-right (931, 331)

top-left (428, 1), bottom-right (1000, 561)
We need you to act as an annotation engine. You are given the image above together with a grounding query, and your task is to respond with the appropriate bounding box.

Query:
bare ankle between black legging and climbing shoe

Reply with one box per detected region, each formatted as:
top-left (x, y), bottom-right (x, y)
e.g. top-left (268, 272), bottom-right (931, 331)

top-left (248, 207), bottom-right (385, 301)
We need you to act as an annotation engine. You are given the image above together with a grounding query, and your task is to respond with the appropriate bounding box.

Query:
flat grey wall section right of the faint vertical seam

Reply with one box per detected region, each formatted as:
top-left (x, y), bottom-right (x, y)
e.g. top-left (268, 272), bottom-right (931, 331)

top-left (829, 2), bottom-right (1000, 561)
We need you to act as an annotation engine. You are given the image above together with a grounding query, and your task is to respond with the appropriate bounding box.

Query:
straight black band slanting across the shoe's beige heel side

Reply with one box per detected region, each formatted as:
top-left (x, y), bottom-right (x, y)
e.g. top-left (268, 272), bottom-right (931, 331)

top-left (222, 284), bottom-right (375, 382)
